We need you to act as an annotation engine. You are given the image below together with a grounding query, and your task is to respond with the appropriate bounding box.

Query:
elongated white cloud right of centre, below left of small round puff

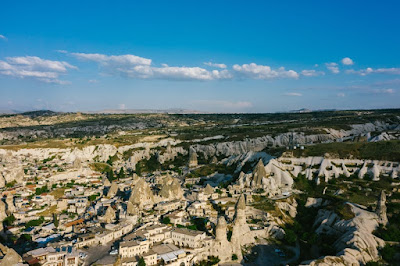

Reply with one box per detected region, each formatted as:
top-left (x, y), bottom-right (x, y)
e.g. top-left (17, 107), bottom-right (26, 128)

top-left (233, 63), bottom-right (299, 79)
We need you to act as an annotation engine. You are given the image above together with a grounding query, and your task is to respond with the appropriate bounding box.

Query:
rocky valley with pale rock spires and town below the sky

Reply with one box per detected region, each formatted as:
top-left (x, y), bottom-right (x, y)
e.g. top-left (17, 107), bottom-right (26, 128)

top-left (0, 109), bottom-right (400, 265)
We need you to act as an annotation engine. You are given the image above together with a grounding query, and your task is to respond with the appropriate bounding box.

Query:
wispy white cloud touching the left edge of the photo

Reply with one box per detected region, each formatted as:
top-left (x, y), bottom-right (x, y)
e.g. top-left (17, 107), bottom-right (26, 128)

top-left (0, 56), bottom-right (77, 84)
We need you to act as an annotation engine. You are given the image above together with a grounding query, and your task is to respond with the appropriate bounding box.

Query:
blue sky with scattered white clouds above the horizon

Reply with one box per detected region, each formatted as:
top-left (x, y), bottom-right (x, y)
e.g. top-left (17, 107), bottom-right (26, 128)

top-left (0, 1), bottom-right (400, 112)
